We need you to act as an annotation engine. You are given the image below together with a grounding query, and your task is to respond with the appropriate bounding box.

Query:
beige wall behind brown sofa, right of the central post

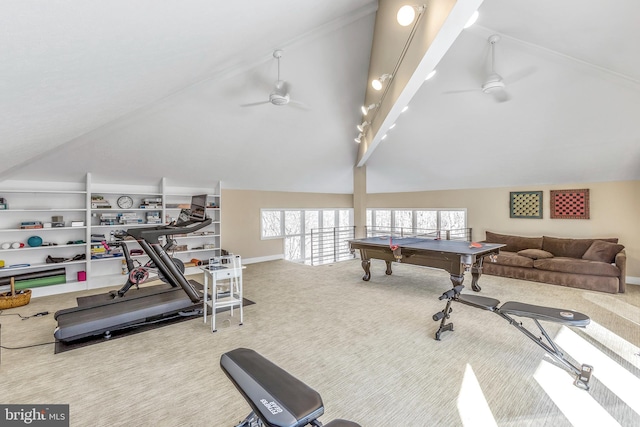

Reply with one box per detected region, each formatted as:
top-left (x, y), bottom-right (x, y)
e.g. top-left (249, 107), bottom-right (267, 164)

top-left (367, 181), bottom-right (640, 278)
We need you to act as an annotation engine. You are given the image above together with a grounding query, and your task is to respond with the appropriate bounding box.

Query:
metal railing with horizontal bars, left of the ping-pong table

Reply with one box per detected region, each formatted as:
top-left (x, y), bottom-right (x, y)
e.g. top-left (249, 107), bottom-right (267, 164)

top-left (310, 226), bottom-right (356, 265)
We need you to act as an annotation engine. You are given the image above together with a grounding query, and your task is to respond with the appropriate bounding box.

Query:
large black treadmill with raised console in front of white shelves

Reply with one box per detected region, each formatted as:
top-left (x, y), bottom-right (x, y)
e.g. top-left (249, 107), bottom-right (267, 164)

top-left (53, 195), bottom-right (211, 343)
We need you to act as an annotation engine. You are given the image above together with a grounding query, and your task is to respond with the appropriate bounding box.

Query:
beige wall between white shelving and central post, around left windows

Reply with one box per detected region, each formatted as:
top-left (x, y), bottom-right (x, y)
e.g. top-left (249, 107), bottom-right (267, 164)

top-left (220, 189), bottom-right (353, 259)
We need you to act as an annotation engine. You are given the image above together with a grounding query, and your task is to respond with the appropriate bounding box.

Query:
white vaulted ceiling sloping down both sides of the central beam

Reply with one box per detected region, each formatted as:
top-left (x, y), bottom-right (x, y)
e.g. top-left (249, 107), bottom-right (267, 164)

top-left (0, 0), bottom-right (640, 193)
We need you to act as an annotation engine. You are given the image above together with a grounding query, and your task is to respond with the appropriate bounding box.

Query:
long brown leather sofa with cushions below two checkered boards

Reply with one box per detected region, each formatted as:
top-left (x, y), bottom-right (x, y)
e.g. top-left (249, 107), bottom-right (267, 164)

top-left (482, 231), bottom-right (627, 293)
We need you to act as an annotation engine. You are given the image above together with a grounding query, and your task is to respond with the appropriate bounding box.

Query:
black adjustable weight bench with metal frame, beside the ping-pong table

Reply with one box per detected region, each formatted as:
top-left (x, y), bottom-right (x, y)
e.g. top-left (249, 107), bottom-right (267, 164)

top-left (433, 285), bottom-right (593, 390)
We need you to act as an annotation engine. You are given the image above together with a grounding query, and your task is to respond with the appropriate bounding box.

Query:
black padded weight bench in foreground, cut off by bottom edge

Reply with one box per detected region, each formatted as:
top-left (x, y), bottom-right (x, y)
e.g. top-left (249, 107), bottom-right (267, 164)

top-left (220, 348), bottom-right (360, 427)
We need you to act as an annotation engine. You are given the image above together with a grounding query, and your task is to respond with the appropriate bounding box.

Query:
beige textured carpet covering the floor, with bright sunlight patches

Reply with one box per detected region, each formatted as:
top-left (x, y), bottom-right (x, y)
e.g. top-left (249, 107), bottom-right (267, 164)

top-left (0, 260), bottom-right (640, 427)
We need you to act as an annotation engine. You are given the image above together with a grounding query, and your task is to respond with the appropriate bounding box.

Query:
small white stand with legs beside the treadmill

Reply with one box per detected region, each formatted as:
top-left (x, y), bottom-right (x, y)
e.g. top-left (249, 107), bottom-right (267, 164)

top-left (201, 255), bottom-right (244, 332)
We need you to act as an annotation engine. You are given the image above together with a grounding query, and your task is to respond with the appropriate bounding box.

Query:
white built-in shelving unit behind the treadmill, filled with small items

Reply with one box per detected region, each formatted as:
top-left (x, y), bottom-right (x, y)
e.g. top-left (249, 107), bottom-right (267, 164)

top-left (0, 174), bottom-right (221, 296)
